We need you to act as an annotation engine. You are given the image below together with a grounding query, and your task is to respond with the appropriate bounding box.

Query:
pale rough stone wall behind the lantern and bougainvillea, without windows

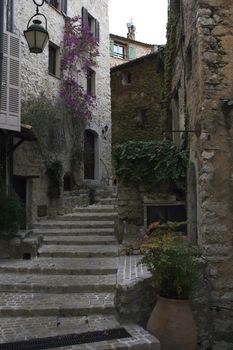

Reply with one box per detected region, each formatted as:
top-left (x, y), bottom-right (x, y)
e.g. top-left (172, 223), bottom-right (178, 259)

top-left (14, 0), bottom-right (111, 220)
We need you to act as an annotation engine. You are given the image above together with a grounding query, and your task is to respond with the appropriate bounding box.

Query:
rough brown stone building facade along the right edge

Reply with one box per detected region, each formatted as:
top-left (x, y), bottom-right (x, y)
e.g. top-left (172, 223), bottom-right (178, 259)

top-left (168, 0), bottom-right (233, 350)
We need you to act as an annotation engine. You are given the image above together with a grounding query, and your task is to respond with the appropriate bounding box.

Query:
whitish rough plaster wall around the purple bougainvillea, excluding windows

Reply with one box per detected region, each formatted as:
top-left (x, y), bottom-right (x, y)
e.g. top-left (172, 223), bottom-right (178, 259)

top-left (15, 0), bottom-right (111, 185)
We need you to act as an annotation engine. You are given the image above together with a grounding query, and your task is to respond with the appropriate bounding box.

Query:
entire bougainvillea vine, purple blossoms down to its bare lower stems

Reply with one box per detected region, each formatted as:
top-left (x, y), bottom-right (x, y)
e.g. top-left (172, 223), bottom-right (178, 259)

top-left (60, 16), bottom-right (99, 166)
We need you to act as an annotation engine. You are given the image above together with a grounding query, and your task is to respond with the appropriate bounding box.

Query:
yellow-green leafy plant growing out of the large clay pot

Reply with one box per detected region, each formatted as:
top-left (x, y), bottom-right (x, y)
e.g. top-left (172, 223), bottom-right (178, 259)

top-left (141, 222), bottom-right (199, 299)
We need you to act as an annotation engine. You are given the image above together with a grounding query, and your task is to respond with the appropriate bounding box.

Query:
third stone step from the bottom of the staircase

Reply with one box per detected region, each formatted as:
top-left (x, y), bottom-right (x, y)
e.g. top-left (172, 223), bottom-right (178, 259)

top-left (0, 273), bottom-right (116, 294)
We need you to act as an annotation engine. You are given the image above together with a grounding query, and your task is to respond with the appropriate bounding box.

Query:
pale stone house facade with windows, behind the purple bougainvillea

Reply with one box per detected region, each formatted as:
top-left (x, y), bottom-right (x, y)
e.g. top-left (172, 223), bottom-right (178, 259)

top-left (11, 0), bottom-right (111, 224)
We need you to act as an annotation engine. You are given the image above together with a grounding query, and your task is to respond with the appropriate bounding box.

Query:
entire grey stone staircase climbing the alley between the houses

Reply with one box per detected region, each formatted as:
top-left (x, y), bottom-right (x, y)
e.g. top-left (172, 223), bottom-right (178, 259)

top-left (0, 190), bottom-right (159, 350)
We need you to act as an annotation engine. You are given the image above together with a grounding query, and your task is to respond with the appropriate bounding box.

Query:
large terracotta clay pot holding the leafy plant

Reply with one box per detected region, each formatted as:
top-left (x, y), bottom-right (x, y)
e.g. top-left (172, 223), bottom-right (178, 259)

top-left (147, 297), bottom-right (197, 350)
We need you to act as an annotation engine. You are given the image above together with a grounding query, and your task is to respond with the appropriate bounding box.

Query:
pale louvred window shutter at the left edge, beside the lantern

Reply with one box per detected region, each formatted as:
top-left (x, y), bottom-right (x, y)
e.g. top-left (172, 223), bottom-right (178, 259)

top-left (0, 32), bottom-right (21, 131)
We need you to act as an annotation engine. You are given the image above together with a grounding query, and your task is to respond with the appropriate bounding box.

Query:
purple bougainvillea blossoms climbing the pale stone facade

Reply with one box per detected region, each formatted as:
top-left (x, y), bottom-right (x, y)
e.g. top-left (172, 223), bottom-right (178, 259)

top-left (61, 17), bottom-right (99, 118)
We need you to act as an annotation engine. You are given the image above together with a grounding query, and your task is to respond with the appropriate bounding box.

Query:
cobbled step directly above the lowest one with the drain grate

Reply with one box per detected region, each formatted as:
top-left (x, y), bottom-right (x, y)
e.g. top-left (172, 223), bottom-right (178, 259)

top-left (0, 292), bottom-right (114, 317)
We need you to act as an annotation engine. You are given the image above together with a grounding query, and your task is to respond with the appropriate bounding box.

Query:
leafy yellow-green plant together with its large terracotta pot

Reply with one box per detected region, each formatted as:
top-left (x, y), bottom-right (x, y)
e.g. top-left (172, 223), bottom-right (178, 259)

top-left (141, 222), bottom-right (198, 350)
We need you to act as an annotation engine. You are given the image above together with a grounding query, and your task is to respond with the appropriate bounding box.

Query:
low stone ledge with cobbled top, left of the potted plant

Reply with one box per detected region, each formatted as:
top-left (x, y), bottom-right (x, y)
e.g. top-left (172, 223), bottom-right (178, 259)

top-left (116, 255), bottom-right (156, 326)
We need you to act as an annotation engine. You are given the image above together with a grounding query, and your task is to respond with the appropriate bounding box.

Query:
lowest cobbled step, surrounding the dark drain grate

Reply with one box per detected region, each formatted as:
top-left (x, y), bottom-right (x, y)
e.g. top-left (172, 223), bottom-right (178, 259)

top-left (0, 315), bottom-right (160, 350)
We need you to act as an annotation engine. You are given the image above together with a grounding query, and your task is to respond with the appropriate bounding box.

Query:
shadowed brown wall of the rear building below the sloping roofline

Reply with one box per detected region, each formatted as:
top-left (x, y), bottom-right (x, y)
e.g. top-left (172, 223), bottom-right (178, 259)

top-left (111, 53), bottom-right (163, 146)
